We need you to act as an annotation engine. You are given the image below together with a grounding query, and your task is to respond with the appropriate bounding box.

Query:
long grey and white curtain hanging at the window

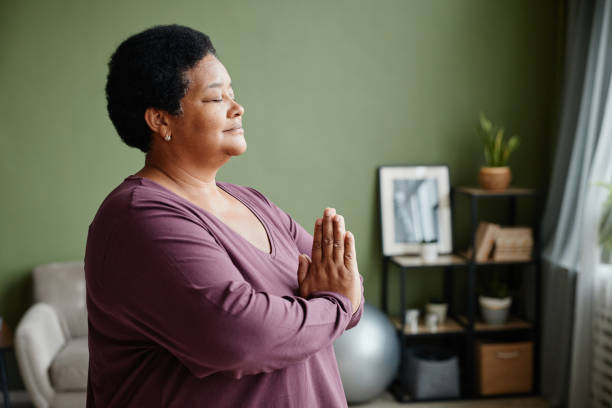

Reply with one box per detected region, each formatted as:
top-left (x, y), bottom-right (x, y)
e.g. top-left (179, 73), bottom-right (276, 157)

top-left (542, 0), bottom-right (612, 408)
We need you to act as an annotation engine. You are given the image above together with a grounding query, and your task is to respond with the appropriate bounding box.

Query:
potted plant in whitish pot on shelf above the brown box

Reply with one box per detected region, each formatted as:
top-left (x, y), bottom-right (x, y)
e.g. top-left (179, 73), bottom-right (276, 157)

top-left (478, 271), bottom-right (512, 324)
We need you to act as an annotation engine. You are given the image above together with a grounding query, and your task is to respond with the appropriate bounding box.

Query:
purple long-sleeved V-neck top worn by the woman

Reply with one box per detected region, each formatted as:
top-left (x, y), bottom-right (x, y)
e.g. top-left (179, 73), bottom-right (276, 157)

top-left (85, 176), bottom-right (364, 408)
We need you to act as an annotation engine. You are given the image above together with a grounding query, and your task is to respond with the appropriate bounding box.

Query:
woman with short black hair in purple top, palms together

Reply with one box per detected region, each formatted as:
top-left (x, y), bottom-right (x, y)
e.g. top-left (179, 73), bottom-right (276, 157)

top-left (85, 25), bottom-right (364, 408)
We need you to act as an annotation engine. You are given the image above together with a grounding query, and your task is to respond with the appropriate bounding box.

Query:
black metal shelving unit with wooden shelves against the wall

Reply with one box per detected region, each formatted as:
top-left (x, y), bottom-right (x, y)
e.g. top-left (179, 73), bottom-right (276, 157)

top-left (382, 187), bottom-right (541, 402)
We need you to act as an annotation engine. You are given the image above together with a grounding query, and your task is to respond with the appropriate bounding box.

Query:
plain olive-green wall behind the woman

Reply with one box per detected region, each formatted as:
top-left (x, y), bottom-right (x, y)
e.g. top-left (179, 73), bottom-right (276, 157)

top-left (0, 0), bottom-right (560, 388)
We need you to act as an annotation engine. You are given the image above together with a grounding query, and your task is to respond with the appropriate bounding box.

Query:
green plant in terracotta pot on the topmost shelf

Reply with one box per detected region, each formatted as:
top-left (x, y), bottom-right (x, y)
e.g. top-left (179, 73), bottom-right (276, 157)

top-left (477, 112), bottom-right (519, 191)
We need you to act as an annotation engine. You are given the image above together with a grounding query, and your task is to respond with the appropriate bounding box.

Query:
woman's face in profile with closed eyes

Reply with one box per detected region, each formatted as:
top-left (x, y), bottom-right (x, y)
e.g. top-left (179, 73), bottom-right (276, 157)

top-left (170, 55), bottom-right (246, 167)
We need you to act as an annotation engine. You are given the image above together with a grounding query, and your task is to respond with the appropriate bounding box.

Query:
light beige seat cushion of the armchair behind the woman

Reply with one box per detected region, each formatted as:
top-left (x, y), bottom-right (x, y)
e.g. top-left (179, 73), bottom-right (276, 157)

top-left (49, 337), bottom-right (89, 392)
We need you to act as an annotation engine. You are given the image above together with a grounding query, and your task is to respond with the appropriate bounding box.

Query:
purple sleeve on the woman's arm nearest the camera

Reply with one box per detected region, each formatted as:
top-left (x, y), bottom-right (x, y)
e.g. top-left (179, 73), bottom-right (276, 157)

top-left (104, 196), bottom-right (351, 379)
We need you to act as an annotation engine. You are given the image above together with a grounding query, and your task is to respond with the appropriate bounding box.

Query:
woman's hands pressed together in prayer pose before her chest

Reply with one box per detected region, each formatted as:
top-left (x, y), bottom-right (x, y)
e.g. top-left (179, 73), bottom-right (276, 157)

top-left (298, 208), bottom-right (361, 313)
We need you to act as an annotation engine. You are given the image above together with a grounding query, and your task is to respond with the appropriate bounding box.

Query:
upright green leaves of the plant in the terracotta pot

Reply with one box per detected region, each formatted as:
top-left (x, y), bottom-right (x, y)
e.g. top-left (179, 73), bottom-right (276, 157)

top-left (477, 112), bottom-right (520, 167)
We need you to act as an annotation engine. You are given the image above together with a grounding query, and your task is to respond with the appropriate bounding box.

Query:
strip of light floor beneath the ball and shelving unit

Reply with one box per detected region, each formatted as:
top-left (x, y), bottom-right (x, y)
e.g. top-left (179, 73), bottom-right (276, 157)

top-left (349, 392), bottom-right (548, 408)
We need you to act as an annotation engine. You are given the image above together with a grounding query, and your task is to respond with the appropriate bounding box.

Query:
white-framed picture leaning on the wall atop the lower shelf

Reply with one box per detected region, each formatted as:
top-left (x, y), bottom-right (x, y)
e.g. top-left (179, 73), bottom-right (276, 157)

top-left (378, 166), bottom-right (453, 256)
